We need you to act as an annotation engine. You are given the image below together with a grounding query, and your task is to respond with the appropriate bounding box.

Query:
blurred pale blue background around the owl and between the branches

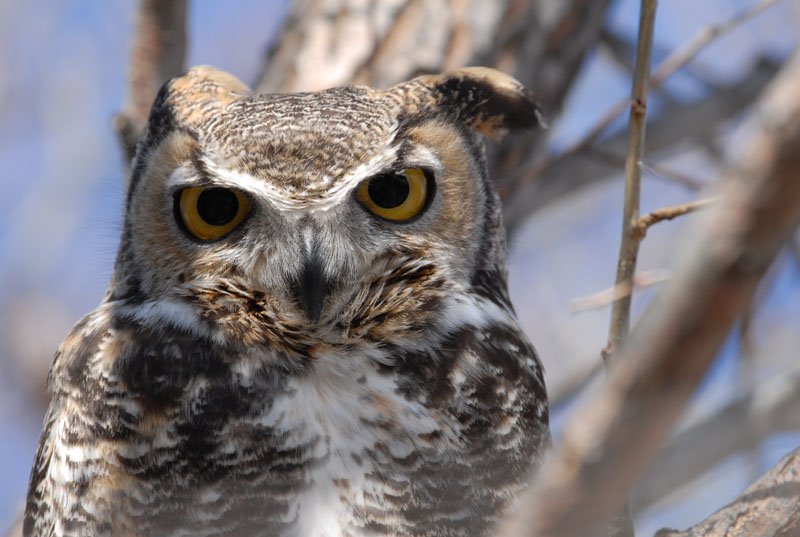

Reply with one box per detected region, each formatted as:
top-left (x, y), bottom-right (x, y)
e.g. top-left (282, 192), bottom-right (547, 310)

top-left (0, 0), bottom-right (800, 535)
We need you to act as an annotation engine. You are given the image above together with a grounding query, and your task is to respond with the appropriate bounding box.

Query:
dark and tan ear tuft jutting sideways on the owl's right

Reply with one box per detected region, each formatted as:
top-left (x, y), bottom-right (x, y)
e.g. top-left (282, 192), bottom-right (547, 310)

top-left (416, 67), bottom-right (546, 138)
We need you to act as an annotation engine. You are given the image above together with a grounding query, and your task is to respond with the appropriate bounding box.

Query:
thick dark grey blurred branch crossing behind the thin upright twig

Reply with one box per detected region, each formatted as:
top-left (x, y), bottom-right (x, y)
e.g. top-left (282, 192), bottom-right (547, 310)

top-left (501, 60), bottom-right (778, 236)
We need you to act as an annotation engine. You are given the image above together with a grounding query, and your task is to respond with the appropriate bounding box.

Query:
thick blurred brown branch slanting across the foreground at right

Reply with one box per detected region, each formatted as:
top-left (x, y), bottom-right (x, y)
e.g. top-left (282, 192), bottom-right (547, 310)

top-left (500, 45), bottom-right (800, 537)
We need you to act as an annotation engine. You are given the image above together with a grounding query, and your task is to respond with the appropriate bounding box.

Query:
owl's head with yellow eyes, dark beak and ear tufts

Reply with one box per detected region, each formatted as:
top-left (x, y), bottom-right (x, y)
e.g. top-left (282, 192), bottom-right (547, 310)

top-left (109, 67), bottom-right (540, 353)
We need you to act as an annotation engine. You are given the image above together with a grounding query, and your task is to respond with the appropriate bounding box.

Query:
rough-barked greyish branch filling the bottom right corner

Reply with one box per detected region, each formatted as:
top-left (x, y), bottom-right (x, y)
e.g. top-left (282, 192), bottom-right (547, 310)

top-left (655, 448), bottom-right (800, 537)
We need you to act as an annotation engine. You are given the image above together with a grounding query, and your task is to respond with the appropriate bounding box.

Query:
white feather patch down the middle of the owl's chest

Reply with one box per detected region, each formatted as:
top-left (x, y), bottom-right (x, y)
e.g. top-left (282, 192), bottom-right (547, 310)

top-left (250, 353), bottom-right (446, 537)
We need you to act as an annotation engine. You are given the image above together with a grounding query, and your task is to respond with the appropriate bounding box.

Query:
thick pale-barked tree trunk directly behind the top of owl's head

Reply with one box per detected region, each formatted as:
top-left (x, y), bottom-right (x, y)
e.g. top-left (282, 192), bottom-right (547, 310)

top-left (255, 0), bottom-right (609, 99)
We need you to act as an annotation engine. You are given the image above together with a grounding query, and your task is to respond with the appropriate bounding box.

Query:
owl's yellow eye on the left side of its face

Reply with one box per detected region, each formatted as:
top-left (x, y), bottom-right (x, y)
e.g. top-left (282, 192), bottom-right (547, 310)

top-left (178, 186), bottom-right (250, 241)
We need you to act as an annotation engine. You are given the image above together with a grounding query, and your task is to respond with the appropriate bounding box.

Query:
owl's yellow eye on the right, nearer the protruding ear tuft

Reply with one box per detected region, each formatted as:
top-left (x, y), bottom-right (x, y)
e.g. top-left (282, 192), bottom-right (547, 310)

top-left (357, 168), bottom-right (428, 222)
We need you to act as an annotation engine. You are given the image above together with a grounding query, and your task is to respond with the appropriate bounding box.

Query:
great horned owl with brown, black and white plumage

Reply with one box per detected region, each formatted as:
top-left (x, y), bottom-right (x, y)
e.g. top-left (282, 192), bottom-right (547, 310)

top-left (24, 67), bottom-right (549, 537)
